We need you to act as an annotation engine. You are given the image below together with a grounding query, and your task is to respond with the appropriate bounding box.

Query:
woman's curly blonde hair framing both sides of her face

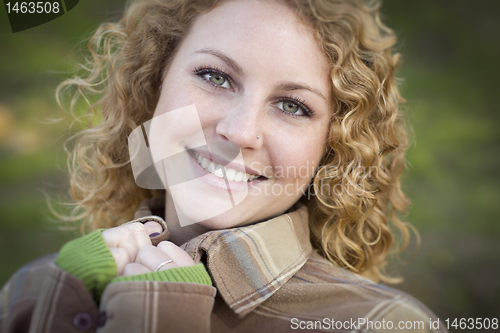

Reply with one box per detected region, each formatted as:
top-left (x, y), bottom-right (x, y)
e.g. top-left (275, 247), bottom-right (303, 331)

top-left (56, 0), bottom-right (409, 282)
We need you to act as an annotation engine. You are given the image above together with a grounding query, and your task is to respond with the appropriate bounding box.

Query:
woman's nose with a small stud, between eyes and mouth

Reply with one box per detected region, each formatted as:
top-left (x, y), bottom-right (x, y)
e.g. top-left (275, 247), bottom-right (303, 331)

top-left (215, 99), bottom-right (265, 150)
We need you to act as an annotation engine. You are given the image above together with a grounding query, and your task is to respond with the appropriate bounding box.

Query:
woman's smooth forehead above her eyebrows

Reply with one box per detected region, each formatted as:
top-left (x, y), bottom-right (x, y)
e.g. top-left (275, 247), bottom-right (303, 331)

top-left (181, 0), bottom-right (329, 94)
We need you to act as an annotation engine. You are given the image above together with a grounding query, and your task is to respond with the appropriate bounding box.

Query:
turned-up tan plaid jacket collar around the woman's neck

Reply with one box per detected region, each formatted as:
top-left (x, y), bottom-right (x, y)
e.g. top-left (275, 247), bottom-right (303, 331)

top-left (135, 197), bottom-right (312, 317)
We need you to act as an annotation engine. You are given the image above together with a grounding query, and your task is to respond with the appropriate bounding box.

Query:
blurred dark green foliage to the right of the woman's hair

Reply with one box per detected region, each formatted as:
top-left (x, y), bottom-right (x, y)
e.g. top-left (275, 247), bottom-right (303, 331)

top-left (383, 0), bottom-right (500, 319)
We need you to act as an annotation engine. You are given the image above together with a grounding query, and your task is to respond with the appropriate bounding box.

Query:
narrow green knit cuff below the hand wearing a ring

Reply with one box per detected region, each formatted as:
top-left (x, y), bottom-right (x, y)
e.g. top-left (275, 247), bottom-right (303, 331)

top-left (111, 263), bottom-right (212, 286)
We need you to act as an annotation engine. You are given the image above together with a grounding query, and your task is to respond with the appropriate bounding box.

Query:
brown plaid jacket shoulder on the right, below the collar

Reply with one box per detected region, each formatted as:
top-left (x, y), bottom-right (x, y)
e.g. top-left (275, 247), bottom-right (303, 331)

top-left (259, 253), bottom-right (446, 332)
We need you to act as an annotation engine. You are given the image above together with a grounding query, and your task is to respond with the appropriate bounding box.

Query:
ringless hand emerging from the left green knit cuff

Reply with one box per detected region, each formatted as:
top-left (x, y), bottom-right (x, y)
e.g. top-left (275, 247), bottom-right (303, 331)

top-left (102, 222), bottom-right (151, 262)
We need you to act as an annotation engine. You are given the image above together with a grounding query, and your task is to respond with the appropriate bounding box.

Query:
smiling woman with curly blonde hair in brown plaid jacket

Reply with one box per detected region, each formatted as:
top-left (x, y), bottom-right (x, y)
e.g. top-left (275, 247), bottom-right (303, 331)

top-left (0, 0), bottom-right (444, 332)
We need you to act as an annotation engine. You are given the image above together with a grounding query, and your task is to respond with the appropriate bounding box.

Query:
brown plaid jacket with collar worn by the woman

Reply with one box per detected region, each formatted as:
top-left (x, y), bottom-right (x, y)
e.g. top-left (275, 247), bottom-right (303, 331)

top-left (0, 198), bottom-right (446, 333)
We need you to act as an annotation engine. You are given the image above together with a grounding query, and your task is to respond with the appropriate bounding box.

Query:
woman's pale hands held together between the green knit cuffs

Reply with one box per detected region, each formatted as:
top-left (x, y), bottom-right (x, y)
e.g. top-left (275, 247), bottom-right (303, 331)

top-left (102, 222), bottom-right (195, 276)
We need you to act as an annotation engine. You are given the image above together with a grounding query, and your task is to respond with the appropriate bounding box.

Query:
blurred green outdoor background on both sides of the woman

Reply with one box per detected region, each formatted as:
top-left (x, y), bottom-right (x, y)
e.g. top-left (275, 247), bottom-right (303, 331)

top-left (0, 0), bottom-right (500, 330)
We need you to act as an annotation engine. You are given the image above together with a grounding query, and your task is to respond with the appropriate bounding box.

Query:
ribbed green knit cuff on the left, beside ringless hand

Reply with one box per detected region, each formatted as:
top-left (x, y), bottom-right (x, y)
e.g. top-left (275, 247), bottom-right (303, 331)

top-left (56, 229), bottom-right (117, 300)
